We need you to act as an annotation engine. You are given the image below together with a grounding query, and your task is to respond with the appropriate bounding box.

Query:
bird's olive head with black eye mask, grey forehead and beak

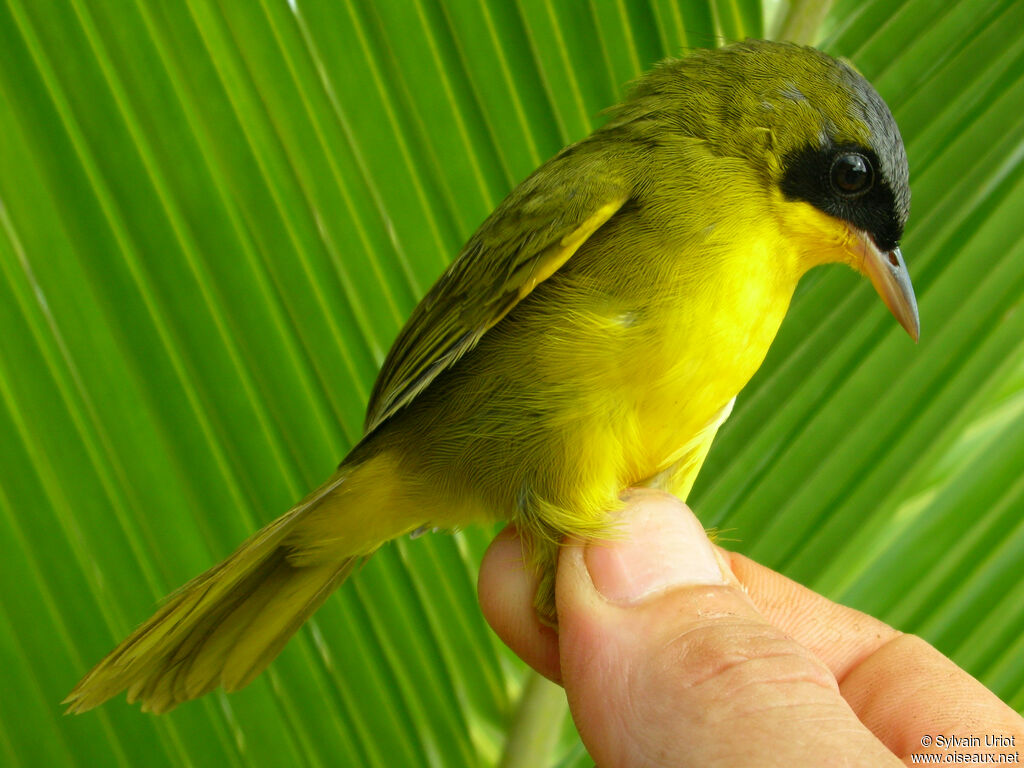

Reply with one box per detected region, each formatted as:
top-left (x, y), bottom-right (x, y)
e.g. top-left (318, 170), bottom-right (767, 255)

top-left (621, 40), bottom-right (920, 341)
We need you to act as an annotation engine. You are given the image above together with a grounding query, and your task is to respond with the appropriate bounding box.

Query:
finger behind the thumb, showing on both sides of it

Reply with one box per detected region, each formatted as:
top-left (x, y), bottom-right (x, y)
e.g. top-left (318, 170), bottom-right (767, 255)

top-left (480, 505), bottom-right (1024, 756)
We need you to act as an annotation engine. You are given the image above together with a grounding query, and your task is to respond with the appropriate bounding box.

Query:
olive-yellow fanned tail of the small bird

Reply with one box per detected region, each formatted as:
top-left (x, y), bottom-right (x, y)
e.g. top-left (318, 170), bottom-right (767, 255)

top-left (63, 462), bottom-right (416, 713)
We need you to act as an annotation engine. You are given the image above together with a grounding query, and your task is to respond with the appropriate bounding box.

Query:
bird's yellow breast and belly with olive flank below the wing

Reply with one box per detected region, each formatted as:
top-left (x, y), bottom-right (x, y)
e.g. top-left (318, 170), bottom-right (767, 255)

top-left (377, 180), bottom-right (804, 540)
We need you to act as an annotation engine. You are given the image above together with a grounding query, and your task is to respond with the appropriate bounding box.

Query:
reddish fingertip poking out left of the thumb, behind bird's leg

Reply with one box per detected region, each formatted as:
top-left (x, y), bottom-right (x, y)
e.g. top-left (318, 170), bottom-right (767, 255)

top-left (476, 525), bottom-right (561, 683)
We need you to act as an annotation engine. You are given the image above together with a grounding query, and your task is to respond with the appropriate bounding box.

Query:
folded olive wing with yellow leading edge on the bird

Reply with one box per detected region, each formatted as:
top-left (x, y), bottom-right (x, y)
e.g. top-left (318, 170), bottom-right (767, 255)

top-left (366, 144), bottom-right (629, 434)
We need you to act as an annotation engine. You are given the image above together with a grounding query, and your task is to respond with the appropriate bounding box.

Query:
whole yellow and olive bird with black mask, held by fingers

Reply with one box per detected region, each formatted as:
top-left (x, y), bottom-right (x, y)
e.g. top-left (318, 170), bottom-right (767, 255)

top-left (67, 41), bottom-right (919, 712)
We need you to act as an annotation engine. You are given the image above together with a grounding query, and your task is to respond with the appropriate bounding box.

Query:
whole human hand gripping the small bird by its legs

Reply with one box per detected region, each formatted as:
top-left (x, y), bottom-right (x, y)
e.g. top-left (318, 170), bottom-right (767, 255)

top-left (479, 489), bottom-right (1024, 768)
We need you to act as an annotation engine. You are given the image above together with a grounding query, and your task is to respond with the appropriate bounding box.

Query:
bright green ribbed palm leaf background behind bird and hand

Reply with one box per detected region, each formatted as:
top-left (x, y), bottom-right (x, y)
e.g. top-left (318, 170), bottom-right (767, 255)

top-left (0, 0), bottom-right (1024, 766)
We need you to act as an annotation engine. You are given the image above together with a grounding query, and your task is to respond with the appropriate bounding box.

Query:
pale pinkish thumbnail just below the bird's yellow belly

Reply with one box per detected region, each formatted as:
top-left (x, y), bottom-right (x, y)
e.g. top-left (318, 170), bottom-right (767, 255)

top-left (585, 492), bottom-right (726, 603)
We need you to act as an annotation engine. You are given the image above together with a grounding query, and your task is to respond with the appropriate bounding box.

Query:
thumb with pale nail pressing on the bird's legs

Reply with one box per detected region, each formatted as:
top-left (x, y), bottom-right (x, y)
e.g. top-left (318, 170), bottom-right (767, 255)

top-left (556, 490), bottom-right (901, 768)
